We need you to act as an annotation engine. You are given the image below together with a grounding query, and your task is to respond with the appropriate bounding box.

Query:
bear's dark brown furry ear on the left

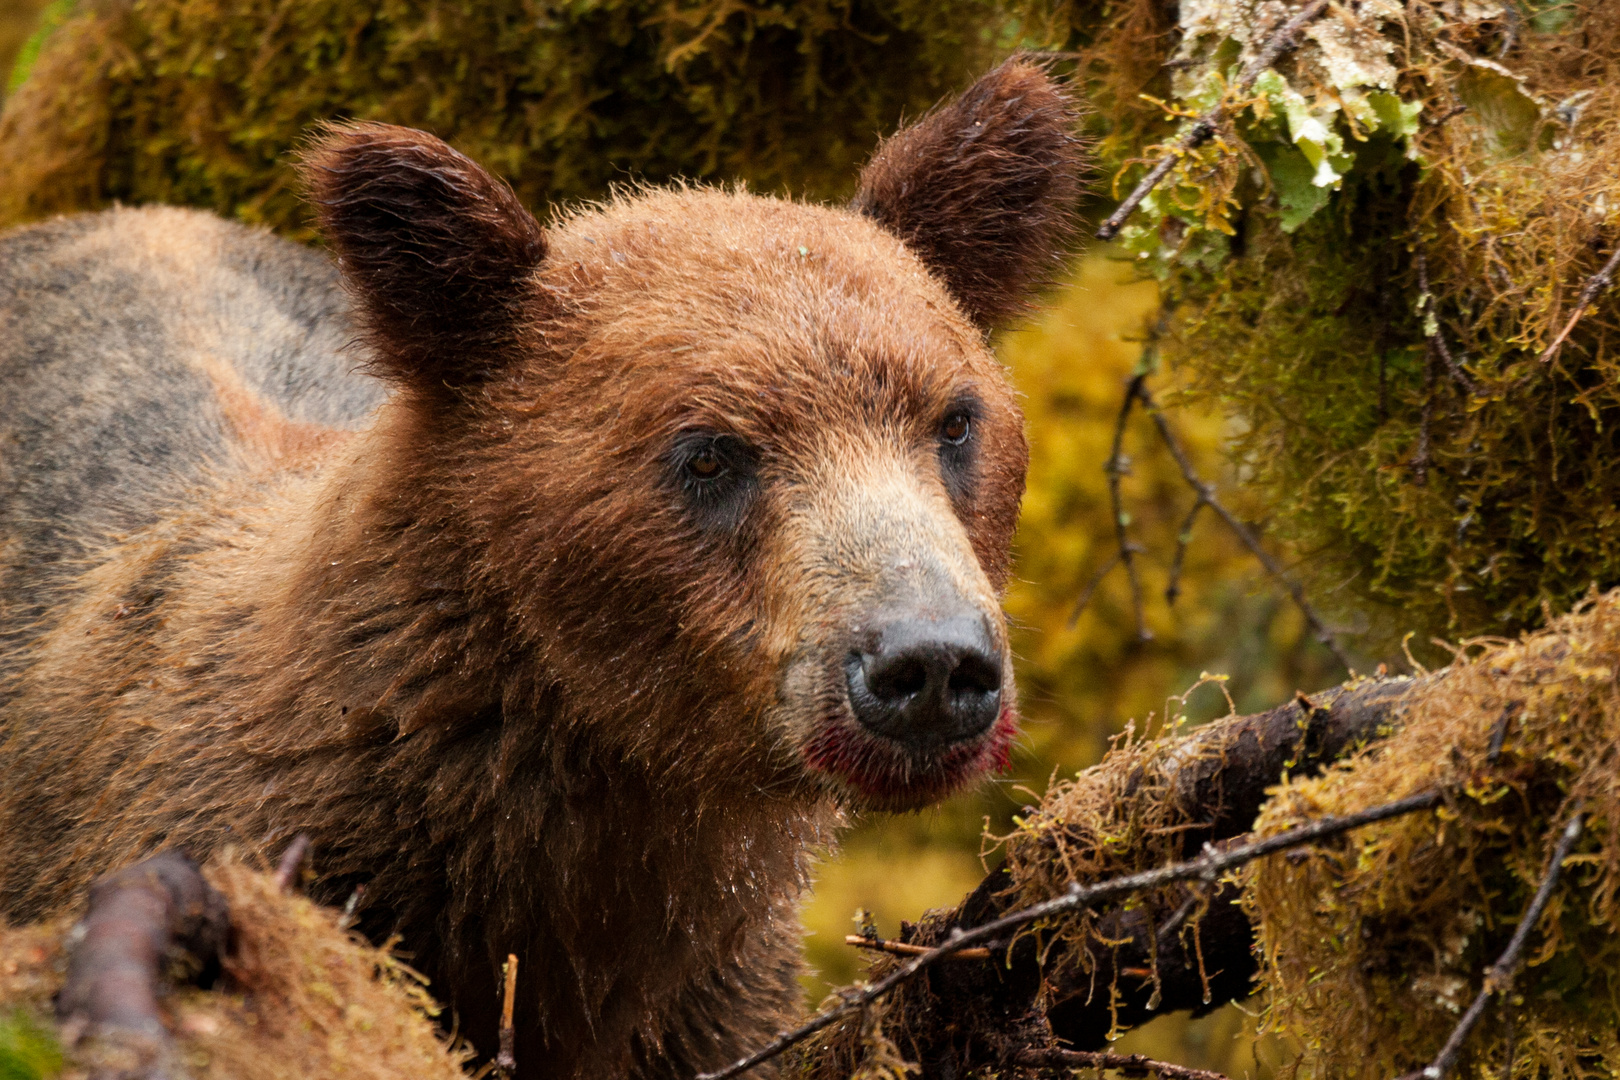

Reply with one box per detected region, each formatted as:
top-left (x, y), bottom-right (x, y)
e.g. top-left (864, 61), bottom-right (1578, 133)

top-left (303, 123), bottom-right (546, 393)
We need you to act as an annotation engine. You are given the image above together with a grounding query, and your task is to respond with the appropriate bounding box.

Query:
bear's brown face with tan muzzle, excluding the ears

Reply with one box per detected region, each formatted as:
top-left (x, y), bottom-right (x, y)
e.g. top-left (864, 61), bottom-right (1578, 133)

top-left (480, 191), bottom-right (1025, 808)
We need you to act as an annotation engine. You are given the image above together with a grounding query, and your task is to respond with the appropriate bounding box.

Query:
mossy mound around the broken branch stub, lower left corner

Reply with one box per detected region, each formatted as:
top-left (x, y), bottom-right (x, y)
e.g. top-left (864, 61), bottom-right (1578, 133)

top-left (0, 858), bottom-right (470, 1080)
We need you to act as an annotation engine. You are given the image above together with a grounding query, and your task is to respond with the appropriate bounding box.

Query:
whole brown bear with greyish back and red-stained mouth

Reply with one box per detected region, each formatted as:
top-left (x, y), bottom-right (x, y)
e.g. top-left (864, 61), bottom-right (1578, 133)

top-left (0, 60), bottom-right (1081, 1077)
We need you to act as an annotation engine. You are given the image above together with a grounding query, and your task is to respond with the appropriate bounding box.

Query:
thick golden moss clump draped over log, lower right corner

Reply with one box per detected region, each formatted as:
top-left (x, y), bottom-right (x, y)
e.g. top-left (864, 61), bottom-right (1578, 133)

top-left (1247, 593), bottom-right (1620, 1080)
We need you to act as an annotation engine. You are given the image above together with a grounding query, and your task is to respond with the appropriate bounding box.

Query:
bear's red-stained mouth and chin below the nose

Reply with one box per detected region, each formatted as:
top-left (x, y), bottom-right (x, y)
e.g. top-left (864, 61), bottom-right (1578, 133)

top-left (800, 701), bottom-right (1017, 810)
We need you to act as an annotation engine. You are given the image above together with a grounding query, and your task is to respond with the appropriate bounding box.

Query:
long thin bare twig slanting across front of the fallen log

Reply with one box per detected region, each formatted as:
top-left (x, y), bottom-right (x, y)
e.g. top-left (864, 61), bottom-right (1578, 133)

top-left (697, 790), bottom-right (1442, 1080)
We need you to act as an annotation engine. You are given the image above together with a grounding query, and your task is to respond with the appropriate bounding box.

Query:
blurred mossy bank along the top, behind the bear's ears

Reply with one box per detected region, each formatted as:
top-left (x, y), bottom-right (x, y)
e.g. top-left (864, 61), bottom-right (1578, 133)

top-left (0, 0), bottom-right (1036, 235)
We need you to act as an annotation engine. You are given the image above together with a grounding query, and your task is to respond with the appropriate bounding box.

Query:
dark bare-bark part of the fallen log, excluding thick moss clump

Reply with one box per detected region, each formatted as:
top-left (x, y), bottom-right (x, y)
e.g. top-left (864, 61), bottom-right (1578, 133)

top-left (805, 675), bottom-right (1437, 1078)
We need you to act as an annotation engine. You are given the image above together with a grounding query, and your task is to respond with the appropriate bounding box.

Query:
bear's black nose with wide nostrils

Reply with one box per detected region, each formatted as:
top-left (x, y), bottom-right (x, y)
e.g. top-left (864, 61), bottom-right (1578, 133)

top-left (844, 617), bottom-right (1001, 751)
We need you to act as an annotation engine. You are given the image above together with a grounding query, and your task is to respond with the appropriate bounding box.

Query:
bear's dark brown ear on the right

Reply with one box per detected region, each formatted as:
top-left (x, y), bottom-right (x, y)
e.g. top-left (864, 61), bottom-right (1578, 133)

top-left (852, 57), bottom-right (1085, 329)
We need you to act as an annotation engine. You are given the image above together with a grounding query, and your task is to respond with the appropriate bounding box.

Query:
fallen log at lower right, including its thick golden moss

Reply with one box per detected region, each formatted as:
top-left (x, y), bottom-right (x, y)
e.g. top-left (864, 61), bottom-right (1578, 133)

top-left (805, 593), bottom-right (1620, 1080)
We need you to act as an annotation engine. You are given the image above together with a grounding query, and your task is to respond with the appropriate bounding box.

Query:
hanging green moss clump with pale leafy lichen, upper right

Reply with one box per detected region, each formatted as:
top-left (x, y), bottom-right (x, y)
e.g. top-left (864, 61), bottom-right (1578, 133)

top-left (1087, 0), bottom-right (1620, 640)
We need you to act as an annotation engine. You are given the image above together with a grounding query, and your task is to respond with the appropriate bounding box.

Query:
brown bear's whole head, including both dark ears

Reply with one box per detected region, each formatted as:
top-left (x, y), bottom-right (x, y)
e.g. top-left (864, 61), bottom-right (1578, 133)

top-left (308, 62), bottom-right (1076, 810)
